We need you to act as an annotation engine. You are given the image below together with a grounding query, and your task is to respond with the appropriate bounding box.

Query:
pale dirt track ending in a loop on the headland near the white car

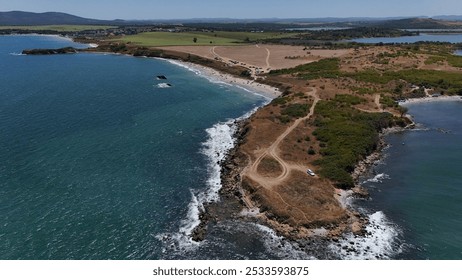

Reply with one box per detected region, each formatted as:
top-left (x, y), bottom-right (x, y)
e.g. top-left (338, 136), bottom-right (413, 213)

top-left (244, 88), bottom-right (319, 189)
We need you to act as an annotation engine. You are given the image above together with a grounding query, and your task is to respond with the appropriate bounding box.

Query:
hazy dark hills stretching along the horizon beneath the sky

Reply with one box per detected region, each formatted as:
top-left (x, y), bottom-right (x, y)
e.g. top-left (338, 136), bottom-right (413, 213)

top-left (0, 11), bottom-right (462, 28)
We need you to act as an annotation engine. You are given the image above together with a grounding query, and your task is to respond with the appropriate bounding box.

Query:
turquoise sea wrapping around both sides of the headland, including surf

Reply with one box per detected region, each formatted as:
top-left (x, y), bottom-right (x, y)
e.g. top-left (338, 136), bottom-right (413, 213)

top-left (0, 36), bottom-right (462, 260)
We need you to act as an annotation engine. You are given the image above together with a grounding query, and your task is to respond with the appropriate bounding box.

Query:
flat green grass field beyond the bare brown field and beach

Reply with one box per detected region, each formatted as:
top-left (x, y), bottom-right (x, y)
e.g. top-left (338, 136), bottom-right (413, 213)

top-left (120, 31), bottom-right (289, 47)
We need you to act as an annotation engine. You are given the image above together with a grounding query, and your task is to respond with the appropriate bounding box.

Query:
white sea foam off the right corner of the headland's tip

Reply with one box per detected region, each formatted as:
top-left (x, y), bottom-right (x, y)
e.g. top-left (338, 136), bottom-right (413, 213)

top-left (329, 211), bottom-right (401, 260)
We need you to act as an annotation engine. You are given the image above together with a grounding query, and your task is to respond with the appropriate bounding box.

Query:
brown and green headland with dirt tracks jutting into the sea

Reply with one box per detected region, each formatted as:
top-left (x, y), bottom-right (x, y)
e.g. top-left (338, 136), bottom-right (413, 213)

top-left (12, 29), bottom-right (462, 255)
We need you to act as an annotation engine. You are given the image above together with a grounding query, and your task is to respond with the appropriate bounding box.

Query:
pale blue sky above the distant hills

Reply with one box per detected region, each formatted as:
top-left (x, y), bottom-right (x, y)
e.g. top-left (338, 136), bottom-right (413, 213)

top-left (0, 0), bottom-right (462, 19)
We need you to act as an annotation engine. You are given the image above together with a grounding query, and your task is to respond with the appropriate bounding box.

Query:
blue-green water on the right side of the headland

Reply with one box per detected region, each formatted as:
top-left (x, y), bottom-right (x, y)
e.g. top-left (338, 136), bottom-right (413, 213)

top-left (360, 101), bottom-right (462, 260)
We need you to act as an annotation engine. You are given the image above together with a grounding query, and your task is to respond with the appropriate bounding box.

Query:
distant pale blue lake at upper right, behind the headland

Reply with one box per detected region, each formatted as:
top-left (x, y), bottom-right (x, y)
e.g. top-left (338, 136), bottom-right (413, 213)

top-left (351, 33), bottom-right (462, 44)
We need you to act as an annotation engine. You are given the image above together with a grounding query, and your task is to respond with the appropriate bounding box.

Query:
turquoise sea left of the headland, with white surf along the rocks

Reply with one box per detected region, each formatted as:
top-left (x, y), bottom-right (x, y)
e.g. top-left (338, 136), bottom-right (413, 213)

top-left (0, 36), bottom-right (284, 259)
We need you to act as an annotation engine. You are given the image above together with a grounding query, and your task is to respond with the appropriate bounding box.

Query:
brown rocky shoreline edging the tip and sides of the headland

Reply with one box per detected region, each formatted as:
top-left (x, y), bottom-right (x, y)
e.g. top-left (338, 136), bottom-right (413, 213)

top-left (191, 110), bottom-right (414, 243)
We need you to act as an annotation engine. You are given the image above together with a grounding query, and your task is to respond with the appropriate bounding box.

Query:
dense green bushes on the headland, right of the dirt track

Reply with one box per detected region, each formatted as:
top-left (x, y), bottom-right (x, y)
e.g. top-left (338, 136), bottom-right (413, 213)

top-left (313, 95), bottom-right (395, 189)
